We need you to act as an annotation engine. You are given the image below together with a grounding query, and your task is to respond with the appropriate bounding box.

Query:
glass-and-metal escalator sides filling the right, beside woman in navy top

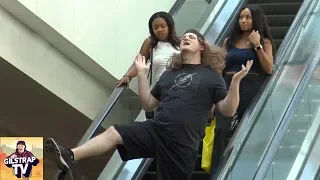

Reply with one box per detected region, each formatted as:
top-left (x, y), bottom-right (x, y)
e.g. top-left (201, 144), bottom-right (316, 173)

top-left (213, 0), bottom-right (320, 180)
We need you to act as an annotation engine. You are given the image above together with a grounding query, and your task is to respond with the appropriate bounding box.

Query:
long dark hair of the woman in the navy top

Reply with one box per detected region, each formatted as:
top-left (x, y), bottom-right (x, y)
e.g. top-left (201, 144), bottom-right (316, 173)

top-left (226, 4), bottom-right (273, 52)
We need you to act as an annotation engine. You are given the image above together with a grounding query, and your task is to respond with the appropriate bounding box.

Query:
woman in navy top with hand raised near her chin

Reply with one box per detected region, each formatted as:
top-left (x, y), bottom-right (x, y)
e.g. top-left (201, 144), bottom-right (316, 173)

top-left (212, 5), bottom-right (273, 173)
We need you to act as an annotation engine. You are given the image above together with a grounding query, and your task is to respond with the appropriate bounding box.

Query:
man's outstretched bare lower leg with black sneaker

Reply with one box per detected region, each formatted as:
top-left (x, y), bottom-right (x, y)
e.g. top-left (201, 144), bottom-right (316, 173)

top-left (45, 126), bottom-right (123, 171)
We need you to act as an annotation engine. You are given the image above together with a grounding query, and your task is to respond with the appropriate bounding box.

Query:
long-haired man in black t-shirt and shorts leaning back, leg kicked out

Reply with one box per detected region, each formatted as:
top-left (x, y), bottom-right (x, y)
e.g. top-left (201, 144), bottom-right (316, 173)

top-left (45, 30), bottom-right (252, 180)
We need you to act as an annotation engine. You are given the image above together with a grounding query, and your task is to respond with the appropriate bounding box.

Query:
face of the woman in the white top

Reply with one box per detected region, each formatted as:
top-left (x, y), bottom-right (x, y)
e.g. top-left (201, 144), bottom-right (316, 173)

top-left (152, 18), bottom-right (169, 41)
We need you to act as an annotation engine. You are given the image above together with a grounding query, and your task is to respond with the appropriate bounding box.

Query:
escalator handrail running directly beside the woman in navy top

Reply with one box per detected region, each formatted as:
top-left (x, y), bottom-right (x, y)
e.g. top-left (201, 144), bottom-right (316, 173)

top-left (212, 0), bottom-right (310, 179)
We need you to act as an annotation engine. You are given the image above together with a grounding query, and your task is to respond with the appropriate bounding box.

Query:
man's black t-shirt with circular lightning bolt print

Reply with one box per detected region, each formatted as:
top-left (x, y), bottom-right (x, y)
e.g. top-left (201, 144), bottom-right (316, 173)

top-left (151, 64), bottom-right (227, 149)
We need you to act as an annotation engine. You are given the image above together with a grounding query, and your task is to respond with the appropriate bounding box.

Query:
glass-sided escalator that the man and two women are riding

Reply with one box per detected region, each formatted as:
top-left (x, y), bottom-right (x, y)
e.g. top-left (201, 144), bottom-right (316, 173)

top-left (49, 0), bottom-right (318, 180)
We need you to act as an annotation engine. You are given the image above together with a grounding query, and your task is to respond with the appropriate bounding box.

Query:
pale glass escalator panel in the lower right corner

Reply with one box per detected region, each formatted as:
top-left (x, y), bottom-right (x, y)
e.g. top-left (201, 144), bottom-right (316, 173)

top-left (255, 52), bottom-right (320, 180)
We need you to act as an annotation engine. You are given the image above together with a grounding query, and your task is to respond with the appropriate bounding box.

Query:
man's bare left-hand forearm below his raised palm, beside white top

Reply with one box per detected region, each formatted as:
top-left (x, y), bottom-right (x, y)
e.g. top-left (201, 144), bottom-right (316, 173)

top-left (138, 71), bottom-right (159, 112)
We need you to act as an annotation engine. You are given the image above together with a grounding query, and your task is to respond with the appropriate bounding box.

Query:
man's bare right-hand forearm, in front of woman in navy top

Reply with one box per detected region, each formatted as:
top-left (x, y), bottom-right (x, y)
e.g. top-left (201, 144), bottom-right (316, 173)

top-left (217, 79), bottom-right (240, 117)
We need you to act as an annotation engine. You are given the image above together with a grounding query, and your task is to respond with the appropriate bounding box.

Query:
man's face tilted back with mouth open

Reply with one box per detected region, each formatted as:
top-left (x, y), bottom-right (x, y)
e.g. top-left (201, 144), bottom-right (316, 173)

top-left (180, 33), bottom-right (203, 53)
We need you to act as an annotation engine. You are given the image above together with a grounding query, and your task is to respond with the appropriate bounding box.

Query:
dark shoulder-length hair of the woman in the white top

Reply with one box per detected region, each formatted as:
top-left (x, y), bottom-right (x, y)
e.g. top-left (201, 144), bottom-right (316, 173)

top-left (148, 11), bottom-right (181, 48)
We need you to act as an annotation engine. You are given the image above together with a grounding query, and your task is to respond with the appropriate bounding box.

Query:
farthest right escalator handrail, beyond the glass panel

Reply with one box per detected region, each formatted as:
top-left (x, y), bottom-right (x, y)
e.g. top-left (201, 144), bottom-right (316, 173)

top-left (254, 24), bottom-right (320, 180)
